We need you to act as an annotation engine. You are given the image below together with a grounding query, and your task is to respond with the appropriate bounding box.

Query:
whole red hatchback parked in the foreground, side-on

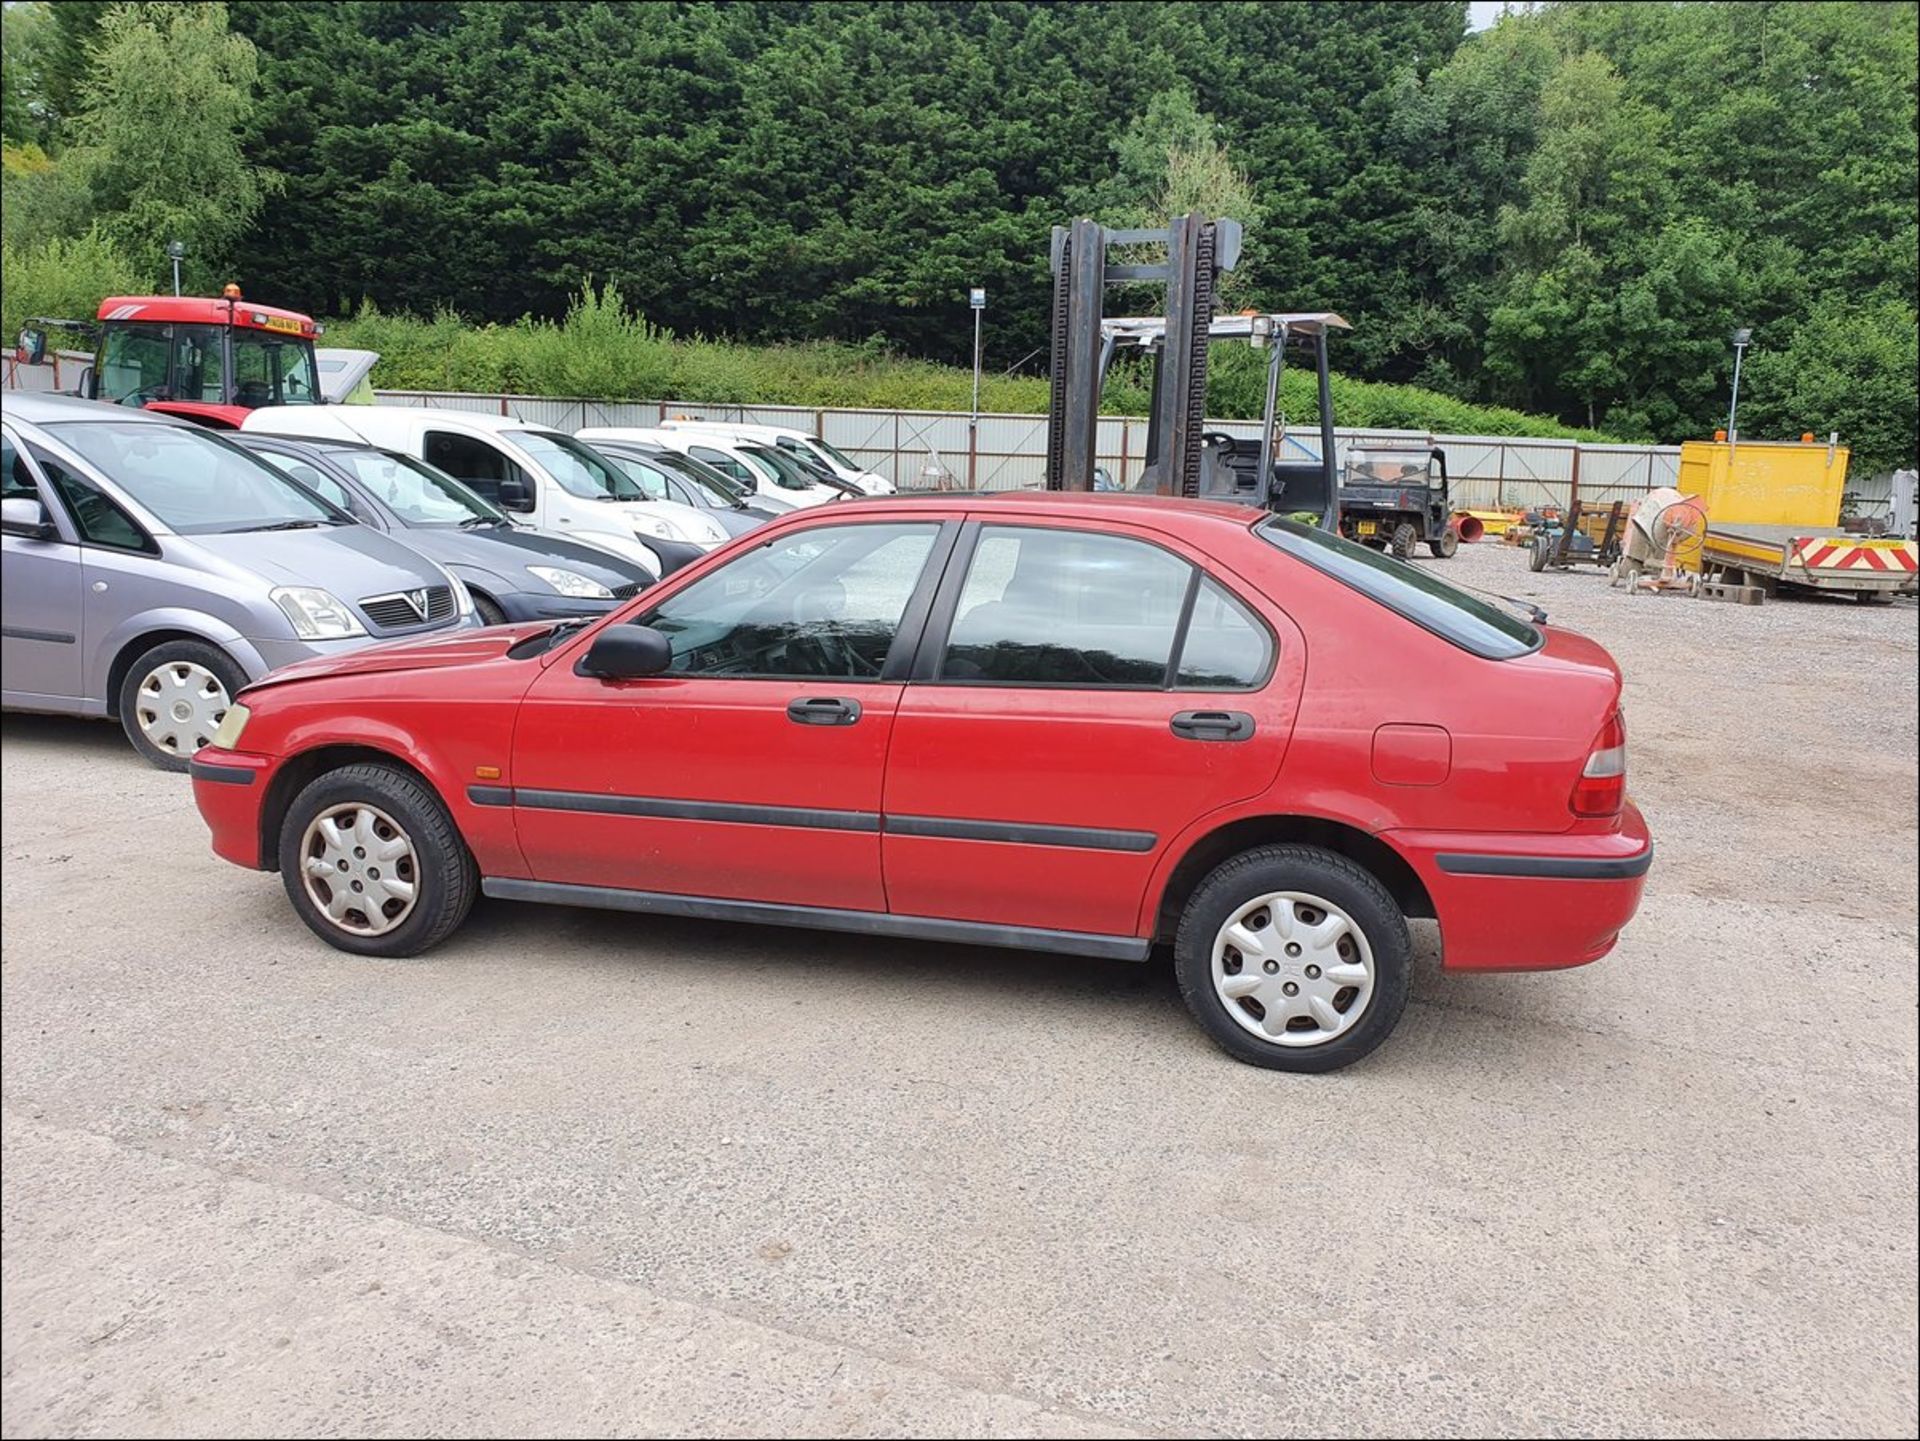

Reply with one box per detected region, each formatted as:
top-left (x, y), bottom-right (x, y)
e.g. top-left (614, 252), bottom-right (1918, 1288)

top-left (192, 493), bottom-right (1653, 1071)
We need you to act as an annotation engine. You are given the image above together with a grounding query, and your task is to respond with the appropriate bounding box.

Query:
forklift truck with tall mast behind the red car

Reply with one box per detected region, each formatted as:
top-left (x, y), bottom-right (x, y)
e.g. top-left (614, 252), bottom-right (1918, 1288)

top-left (1046, 215), bottom-right (1350, 530)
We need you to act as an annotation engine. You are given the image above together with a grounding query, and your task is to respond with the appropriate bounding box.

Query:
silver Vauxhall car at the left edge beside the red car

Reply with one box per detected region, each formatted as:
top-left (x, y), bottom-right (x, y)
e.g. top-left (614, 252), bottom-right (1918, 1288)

top-left (0, 393), bottom-right (478, 771)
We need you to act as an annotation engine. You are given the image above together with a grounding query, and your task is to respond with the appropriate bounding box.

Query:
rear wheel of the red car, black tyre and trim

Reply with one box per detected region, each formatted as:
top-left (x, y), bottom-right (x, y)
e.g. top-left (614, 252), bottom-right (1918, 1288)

top-left (1173, 846), bottom-right (1413, 1071)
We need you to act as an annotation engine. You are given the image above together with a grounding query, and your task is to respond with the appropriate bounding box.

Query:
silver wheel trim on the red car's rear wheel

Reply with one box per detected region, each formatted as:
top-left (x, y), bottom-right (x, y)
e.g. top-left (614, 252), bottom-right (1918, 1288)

top-left (1213, 890), bottom-right (1375, 1048)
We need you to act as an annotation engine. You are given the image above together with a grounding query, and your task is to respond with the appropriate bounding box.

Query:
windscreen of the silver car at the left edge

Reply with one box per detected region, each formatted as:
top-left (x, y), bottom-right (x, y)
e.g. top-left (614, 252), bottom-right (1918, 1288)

top-left (48, 420), bottom-right (349, 535)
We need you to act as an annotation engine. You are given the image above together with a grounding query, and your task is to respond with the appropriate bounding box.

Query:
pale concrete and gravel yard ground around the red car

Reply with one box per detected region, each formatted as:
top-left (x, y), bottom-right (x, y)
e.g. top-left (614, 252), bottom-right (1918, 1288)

top-left (0, 545), bottom-right (1916, 1437)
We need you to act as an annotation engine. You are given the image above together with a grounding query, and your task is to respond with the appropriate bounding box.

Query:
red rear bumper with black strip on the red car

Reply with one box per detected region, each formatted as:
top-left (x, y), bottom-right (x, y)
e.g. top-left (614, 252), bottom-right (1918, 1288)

top-left (1382, 802), bottom-right (1653, 971)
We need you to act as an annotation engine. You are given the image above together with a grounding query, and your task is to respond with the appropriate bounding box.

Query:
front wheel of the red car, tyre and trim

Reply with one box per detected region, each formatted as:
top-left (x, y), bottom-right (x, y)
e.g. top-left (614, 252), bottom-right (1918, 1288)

top-left (278, 764), bottom-right (480, 956)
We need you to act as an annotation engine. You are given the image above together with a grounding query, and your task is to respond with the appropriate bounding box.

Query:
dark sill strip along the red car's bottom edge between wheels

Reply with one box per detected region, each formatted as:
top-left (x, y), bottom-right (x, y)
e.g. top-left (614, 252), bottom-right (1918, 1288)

top-left (480, 877), bottom-right (1152, 961)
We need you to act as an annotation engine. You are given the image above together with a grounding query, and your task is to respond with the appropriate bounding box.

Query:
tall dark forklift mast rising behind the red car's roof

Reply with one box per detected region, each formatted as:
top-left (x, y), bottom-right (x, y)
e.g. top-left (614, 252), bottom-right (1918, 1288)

top-left (1046, 213), bottom-right (1240, 495)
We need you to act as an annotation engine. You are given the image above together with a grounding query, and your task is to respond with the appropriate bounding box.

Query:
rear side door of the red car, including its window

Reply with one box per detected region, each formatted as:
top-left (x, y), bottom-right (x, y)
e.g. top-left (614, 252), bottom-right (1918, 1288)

top-left (883, 524), bottom-right (1304, 934)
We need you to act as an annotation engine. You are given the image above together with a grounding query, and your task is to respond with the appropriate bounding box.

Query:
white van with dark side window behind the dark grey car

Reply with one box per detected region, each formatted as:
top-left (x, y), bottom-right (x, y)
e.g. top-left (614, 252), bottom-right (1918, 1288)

top-left (240, 405), bottom-right (728, 576)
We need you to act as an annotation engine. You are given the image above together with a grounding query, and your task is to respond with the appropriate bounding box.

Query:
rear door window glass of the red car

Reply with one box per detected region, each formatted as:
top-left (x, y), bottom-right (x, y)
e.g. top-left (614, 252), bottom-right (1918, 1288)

top-left (937, 526), bottom-right (1273, 691)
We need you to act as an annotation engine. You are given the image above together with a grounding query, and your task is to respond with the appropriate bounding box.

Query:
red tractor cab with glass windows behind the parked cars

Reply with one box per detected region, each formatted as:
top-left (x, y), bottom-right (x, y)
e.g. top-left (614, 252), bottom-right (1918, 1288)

top-left (81, 286), bottom-right (324, 430)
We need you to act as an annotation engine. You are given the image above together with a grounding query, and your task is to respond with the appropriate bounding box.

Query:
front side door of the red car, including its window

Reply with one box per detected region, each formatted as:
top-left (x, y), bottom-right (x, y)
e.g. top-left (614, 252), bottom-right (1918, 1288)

top-left (501, 518), bottom-right (954, 911)
